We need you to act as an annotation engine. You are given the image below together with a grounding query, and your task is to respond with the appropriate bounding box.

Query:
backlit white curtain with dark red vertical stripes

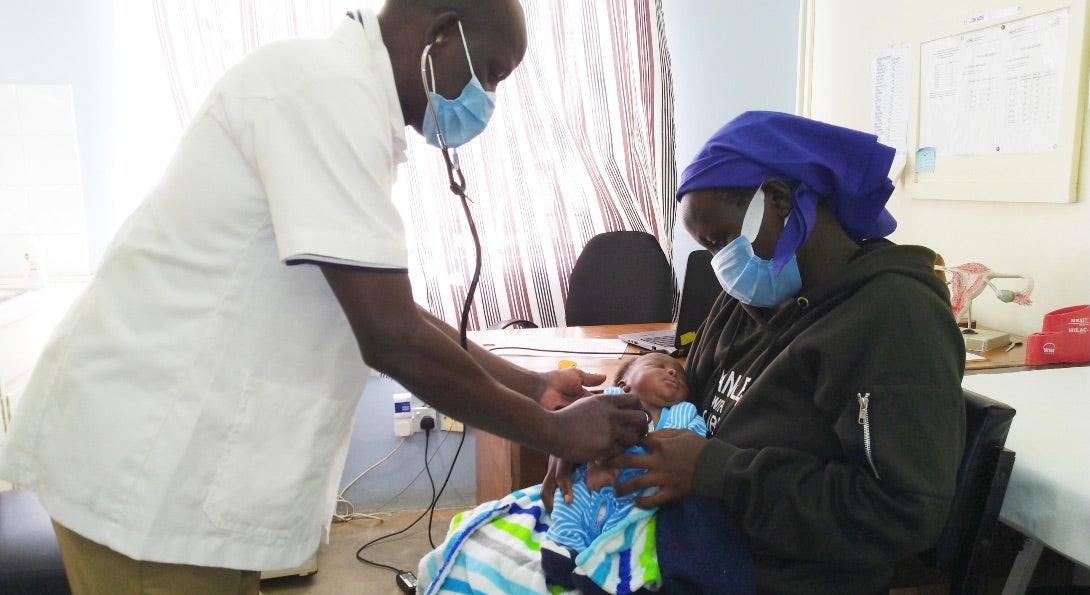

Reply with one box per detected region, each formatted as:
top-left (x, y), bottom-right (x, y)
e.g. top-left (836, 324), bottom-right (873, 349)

top-left (155, 0), bottom-right (677, 329)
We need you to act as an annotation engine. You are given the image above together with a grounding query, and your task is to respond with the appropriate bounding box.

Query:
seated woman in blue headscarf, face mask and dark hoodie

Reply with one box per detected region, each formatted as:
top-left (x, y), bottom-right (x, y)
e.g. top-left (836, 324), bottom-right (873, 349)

top-left (422, 112), bottom-right (965, 594)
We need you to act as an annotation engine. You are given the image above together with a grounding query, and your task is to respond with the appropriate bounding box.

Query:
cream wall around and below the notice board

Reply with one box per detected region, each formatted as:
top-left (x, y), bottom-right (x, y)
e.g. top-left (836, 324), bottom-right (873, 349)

top-left (811, 0), bottom-right (1090, 335)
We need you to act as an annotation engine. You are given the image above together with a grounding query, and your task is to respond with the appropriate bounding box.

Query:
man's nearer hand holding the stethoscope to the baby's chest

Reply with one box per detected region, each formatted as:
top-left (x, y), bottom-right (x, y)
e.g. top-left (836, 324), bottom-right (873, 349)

top-left (547, 394), bottom-right (647, 462)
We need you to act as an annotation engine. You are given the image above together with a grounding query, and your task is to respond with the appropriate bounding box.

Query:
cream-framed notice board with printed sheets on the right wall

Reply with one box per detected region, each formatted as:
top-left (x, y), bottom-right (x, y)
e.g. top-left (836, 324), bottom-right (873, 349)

top-left (803, 0), bottom-right (1090, 203)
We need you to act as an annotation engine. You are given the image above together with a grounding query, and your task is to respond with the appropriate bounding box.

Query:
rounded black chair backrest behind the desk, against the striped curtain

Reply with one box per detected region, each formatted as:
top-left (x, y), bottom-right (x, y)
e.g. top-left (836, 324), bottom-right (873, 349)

top-left (565, 231), bottom-right (677, 326)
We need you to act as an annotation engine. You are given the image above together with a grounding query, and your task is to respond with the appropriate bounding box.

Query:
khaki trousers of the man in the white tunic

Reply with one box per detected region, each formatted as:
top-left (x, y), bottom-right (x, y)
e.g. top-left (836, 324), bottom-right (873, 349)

top-left (53, 522), bottom-right (262, 595)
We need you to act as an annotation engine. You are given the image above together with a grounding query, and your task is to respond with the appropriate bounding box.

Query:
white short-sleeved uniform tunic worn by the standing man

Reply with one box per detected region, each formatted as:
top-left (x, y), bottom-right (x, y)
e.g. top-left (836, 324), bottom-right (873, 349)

top-left (0, 13), bottom-right (407, 570)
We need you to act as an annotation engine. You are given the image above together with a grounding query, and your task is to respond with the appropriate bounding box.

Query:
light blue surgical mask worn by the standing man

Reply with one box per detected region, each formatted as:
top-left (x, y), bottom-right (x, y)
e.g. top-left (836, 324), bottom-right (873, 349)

top-left (420, 21), bottom-right (496, 148)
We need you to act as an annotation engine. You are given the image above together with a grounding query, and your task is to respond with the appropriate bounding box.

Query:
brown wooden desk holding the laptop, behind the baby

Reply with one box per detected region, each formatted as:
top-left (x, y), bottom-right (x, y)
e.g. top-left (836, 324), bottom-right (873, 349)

top-left (473, 323), bottom-right (674, 502)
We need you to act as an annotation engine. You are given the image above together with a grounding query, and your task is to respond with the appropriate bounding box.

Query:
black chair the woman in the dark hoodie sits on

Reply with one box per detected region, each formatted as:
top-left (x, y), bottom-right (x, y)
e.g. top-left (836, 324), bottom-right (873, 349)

top-left (891, 390), bottom-right (1015, 595)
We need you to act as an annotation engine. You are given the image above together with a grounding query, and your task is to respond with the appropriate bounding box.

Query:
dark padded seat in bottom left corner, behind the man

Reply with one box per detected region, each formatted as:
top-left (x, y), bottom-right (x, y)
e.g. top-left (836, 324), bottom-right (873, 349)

top-left (0, 489), bottom-right (72, 595)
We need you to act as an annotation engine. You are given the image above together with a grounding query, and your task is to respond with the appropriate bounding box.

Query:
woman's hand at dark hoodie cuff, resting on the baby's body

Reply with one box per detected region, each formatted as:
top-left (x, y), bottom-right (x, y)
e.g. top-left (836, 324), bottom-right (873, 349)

top-left (606, 429), bottom-right (707, 508)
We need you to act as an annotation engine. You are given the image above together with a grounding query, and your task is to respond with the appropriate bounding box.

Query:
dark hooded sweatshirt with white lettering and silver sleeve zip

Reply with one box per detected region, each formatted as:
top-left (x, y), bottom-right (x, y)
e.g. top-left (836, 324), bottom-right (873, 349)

top-left (688, 240), bottom-right (965, 594)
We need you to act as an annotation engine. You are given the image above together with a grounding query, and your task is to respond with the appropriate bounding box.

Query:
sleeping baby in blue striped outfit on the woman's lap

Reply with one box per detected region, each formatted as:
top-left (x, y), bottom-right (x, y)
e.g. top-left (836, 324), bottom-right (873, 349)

top-left (542, 352), bottom-right (707, 594)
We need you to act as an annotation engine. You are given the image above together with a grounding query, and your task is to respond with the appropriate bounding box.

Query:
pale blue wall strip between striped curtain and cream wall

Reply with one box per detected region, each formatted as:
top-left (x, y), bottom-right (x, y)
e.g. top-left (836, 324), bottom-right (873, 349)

top-left (663, 0), bottom-right (801, 287)
